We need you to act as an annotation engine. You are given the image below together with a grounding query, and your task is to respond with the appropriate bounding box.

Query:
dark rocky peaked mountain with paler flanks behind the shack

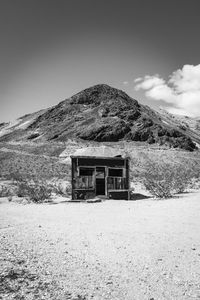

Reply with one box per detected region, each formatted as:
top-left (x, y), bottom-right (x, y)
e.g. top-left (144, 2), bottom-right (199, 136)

top-left (0, 84), bottom-right (200, 151)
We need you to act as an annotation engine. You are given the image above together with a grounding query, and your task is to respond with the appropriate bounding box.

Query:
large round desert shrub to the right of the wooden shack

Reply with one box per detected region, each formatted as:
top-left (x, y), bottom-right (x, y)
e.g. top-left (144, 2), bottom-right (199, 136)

top-left (143, 161), bottom-right (193, 198)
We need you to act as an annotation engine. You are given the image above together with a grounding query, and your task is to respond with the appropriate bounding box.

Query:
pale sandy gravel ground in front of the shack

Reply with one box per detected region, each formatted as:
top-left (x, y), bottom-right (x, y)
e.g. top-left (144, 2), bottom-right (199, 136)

top-left (0, 192), bottom-right (200, 300)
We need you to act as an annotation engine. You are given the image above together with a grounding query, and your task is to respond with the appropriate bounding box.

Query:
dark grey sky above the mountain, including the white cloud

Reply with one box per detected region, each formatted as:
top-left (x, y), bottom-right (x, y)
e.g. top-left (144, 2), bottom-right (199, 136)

top-left (0, 0), bottom-right (200, 122)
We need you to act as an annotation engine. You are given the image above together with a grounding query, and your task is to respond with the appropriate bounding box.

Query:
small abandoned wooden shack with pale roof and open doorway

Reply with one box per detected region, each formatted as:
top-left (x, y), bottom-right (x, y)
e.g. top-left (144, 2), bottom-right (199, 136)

top-left (71, 146), bottom-right (129, 200)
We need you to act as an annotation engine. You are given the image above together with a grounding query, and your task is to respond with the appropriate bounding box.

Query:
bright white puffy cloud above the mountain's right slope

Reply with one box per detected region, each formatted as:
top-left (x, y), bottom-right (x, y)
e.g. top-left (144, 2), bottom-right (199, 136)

top-left (135, 65), bottom-right (200, 116)
